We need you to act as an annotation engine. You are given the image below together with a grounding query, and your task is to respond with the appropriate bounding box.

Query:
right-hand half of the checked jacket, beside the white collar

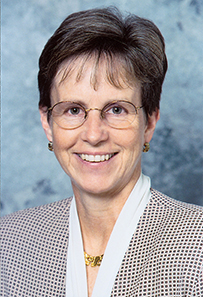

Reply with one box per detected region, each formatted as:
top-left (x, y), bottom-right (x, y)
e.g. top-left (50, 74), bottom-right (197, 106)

top-left (112, 189), bottom-right (203, 296)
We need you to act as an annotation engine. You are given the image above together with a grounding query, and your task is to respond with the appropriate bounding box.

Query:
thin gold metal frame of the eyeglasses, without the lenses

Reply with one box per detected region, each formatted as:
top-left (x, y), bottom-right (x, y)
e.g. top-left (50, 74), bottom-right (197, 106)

top-left (47, 100), bottom-right (144, 130)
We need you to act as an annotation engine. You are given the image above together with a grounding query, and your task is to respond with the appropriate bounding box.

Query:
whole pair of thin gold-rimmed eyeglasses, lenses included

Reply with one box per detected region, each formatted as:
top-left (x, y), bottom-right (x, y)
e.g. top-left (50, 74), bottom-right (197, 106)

top-left (48, 101), bottom-right (143, 130)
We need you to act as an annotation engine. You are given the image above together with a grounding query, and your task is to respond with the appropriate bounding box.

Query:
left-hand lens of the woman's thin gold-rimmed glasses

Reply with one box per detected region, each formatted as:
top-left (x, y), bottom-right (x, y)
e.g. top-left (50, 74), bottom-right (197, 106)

top-left (52, 101), bottom-right (85, 129)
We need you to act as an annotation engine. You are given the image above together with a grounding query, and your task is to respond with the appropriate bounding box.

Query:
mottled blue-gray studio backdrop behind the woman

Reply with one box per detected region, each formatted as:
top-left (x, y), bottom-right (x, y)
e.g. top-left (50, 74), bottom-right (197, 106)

top-left (1, 0), bottom-right (203, 215)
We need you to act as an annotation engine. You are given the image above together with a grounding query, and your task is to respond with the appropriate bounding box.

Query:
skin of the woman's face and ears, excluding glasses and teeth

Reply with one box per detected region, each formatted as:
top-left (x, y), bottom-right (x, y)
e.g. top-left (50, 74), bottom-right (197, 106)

top-left (40, 60), bottom-right (159, 196)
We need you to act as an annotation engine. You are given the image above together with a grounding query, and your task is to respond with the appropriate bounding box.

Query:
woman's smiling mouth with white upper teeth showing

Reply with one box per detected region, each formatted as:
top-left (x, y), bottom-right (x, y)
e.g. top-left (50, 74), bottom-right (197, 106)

top-left (77, 152), bottom-right (117, 163)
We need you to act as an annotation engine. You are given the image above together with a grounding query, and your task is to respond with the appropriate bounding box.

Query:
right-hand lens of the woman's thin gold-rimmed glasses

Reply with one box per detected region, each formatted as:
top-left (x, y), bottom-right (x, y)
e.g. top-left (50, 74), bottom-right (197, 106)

top-left (102, 101), bottom-right (137, 129)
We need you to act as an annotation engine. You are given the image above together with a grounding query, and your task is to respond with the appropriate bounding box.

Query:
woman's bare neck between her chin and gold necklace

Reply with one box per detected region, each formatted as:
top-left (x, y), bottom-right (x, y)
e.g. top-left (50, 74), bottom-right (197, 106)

top-left (73, 180), bottom-right (138, 256)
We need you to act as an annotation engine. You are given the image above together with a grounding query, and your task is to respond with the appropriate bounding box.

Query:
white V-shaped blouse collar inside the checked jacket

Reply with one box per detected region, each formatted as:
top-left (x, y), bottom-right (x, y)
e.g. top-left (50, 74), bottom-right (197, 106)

top-left (66, 174), bottom-right (151, 297)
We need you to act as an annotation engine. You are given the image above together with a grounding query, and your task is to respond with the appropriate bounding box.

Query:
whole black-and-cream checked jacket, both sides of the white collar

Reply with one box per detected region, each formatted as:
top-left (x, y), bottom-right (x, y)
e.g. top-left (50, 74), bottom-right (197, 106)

top-left (1, 190), bottom-right (203, 297)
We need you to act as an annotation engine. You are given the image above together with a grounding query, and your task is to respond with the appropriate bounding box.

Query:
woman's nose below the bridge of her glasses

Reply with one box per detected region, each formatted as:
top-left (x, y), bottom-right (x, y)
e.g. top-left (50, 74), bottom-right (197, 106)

top-left (81, 108), bottom-right (108, 146)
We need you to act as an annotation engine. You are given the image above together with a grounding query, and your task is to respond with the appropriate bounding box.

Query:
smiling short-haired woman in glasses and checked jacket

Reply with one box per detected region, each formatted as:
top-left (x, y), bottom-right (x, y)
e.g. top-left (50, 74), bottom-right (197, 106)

top-left (2, 8), bottom-right (203, 297)
